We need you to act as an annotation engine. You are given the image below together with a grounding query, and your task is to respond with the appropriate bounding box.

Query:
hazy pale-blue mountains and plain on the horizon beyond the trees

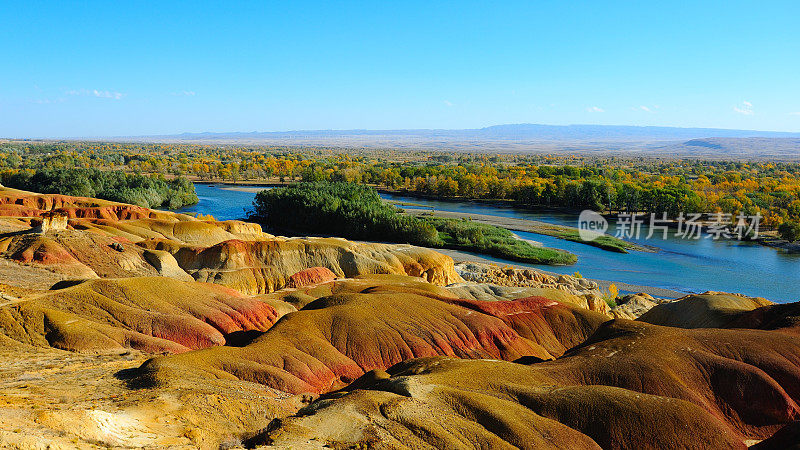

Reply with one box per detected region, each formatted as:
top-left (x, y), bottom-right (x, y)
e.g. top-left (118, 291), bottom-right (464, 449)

top-left (116, 124), bottom-right (800, 159)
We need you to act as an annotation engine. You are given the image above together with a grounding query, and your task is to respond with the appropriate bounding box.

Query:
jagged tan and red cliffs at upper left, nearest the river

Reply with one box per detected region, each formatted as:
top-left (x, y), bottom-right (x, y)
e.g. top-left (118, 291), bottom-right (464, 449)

top-left (0, 188), bottom-right (461, 294)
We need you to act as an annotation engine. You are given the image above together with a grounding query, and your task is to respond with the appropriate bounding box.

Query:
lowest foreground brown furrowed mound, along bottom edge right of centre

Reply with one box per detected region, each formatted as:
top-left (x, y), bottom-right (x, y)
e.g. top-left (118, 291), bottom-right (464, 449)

top-left (268, 364), bottom-right (746, 449)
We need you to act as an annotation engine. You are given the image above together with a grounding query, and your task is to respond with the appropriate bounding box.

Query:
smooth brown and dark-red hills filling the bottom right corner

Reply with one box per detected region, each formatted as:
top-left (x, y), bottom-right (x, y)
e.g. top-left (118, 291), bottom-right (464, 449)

top-left (263, 320), bottom-right (800, 449)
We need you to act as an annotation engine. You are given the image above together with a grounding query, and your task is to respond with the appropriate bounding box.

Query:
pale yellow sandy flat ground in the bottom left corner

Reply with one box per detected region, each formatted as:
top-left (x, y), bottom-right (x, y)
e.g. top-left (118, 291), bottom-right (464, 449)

top-left (0, 337), bottom-right (301, 449)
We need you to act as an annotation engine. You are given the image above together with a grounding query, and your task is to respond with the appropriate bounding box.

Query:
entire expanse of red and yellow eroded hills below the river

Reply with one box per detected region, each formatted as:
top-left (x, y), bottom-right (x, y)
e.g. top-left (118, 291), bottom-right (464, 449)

top-left (0, 188), bottom-right (800, 448)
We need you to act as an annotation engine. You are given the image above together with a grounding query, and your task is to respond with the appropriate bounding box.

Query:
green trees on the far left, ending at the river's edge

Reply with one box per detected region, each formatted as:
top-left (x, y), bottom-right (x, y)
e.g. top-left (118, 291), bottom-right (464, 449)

top-left (0, 169), bottom-right (198, 209)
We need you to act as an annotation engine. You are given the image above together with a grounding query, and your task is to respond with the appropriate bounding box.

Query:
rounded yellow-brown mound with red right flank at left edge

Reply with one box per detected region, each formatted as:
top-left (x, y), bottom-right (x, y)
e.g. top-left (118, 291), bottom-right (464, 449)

top-left (0, 277), bottom-right (278, 353)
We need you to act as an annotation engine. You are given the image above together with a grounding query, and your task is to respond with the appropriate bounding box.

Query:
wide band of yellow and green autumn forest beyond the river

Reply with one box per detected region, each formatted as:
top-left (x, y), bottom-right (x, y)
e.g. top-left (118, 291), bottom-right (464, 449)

top-left (0, 142), bottom-right (800, 236)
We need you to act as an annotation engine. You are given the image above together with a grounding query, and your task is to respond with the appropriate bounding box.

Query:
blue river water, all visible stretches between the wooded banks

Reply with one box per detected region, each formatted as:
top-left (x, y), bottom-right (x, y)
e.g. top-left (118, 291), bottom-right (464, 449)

top-left (180, 184), bottom-right (800, 302)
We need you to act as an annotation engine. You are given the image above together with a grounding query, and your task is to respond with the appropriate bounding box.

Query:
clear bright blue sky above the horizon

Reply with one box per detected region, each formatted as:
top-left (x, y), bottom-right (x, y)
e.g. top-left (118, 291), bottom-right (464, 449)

top-left (0, 0), bottom-right (800, 137)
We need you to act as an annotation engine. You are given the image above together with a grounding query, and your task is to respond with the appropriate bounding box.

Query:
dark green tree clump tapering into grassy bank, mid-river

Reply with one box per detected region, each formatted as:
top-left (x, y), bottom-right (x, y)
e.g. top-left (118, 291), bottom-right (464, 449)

top-left (253, 182), bottom-right (576, 264)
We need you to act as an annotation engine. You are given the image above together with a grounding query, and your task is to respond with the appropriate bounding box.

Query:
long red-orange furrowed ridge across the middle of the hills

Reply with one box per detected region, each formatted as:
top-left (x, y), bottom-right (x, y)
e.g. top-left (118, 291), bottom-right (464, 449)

top-left (134, 281), bottom-right (605, 393)
